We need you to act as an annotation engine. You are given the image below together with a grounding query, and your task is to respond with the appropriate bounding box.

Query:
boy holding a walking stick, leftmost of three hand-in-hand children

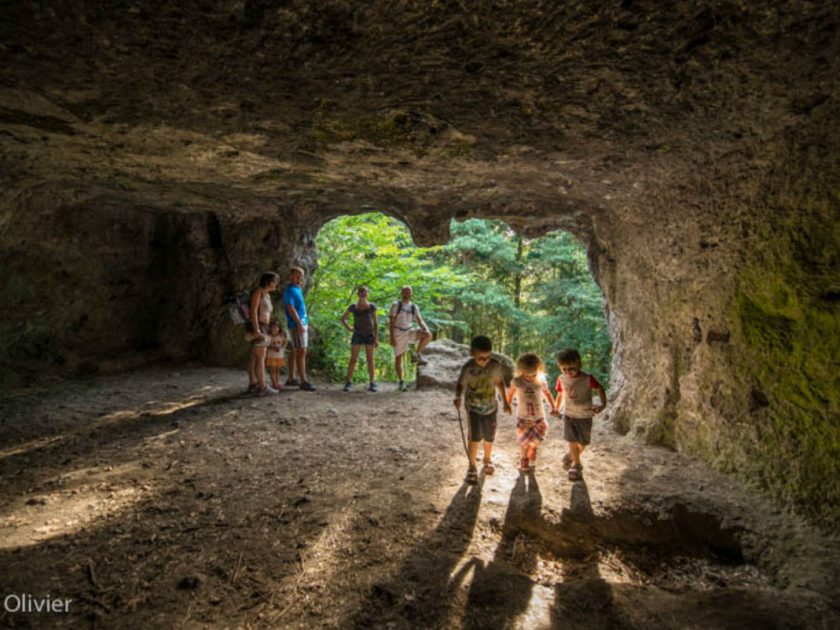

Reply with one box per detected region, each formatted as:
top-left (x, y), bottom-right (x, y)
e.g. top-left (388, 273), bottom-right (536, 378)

top-left (455, 335), bottom-right (510, 483)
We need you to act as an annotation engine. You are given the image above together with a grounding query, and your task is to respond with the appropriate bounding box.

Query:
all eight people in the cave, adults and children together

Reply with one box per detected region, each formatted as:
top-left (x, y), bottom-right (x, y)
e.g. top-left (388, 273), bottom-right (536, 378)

top-left (246, 267), bottom-right (607, 483)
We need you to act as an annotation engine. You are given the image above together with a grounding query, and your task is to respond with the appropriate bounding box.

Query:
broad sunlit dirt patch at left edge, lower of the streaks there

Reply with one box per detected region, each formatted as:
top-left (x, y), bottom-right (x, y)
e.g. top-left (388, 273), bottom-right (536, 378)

top-left (0, 462), bottom-right (152, 550)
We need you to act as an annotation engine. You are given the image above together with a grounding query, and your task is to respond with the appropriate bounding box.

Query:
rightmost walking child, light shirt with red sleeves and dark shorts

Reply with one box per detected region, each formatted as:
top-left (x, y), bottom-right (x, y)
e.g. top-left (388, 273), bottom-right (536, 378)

top-left (554, 348), bottom-right (607, 481)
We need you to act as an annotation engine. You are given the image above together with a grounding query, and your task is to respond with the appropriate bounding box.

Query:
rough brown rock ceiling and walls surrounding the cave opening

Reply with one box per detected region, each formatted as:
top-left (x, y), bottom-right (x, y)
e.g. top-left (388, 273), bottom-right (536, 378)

top-left (0, 0), bottom-right (840, 526)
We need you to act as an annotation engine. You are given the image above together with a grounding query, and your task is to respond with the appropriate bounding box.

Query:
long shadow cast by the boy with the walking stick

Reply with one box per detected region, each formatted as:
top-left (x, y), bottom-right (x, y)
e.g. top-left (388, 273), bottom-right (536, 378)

top-left (340, 483), bottom-right (481, 628)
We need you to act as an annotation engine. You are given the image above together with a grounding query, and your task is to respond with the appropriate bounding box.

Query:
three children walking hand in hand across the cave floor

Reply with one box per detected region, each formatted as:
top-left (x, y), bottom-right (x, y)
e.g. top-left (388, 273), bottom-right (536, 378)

top-left (455, 336), bottom-right (607, 483)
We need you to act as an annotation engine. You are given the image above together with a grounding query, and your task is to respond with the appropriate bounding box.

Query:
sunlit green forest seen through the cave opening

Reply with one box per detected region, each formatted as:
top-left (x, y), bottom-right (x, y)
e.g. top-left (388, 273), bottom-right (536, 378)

top-left (307, 213), bottom-right (611, 383)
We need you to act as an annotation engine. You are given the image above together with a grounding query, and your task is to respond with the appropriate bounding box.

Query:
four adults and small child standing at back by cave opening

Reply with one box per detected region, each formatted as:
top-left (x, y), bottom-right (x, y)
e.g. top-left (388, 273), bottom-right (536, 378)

top-left (245, 267), bottom-right (432, 396)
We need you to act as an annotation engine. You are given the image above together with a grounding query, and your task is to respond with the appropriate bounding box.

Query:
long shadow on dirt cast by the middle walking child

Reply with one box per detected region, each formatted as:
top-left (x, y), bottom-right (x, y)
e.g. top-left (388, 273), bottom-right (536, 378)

top-left (464, 473), bottom-right (542, 628)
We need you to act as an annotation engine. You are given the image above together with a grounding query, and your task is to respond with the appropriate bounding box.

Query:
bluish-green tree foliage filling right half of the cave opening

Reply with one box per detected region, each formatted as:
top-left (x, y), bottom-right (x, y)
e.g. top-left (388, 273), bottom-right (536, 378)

top-left (442, 219), bottom-right (612, 385)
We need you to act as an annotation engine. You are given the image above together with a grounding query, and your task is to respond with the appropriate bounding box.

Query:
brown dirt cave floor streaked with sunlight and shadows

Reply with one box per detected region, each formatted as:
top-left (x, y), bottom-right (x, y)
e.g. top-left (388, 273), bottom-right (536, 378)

top-left (0, 367), bottom-right (840, 628)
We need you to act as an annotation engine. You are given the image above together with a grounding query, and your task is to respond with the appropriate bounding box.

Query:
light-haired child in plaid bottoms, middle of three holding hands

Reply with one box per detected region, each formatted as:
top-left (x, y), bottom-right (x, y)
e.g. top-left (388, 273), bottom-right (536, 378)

top-left (507, 352), bottom-right (554, 472)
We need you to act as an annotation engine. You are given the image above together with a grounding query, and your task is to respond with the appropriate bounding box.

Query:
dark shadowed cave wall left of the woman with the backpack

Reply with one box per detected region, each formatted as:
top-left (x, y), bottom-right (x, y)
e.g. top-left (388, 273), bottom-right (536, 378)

top-left (0, 190), bottom-right (315, 386)
